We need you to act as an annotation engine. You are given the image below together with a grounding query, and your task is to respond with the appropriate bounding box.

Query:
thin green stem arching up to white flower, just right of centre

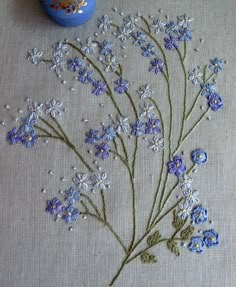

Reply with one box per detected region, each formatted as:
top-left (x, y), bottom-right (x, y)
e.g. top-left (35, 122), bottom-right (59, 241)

top-left (146, 98), bottom-right (165, 230)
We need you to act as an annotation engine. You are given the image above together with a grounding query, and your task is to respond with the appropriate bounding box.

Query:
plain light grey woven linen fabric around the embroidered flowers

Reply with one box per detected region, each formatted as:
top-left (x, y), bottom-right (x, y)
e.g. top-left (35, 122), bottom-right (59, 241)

top-left (0, 0), bottom-right (236, 287)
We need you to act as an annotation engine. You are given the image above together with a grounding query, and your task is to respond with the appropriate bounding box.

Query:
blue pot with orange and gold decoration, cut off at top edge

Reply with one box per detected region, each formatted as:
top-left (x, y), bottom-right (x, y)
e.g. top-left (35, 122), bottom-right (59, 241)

top-left (40, 0), bottom-right (96, 27)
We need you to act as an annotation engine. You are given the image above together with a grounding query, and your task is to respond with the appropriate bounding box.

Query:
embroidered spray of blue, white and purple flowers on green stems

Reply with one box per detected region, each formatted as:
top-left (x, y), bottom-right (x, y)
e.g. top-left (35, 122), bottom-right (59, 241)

top-left (7, 10), bottom-right (225, 286)
